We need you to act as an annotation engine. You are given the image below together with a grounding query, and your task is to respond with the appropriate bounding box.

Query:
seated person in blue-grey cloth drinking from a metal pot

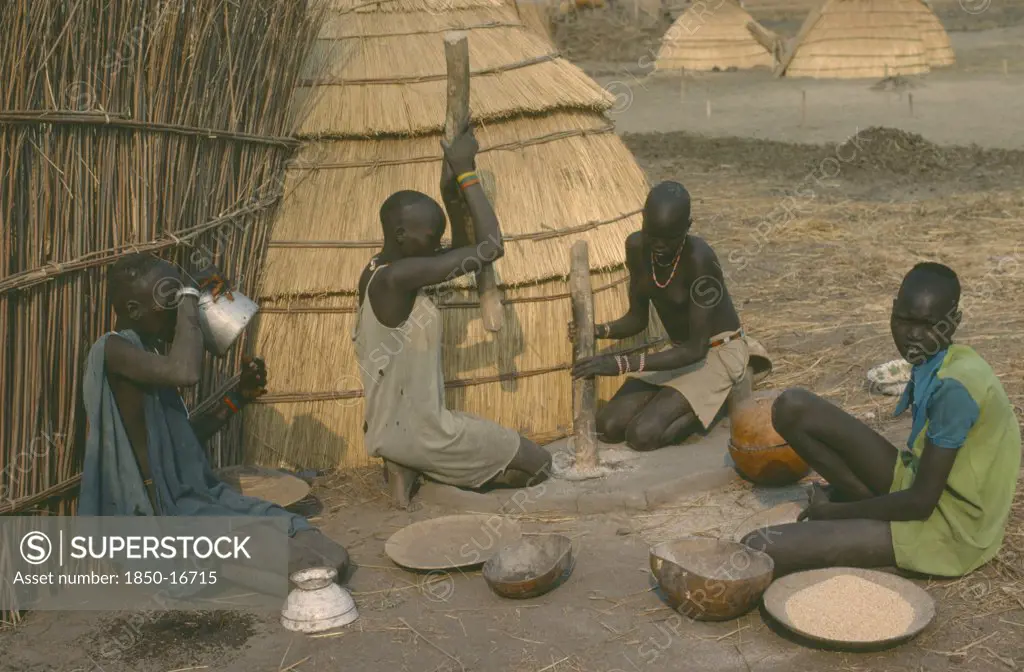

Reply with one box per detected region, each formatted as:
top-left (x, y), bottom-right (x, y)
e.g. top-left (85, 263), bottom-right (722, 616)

top-left (79, 254), bottom-right (348, 576)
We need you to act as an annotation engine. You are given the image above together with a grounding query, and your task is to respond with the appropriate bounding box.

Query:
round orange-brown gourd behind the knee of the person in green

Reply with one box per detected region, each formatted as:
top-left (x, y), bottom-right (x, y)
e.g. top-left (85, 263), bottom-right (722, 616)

top-left (729, 390), bottom-right (810, 488)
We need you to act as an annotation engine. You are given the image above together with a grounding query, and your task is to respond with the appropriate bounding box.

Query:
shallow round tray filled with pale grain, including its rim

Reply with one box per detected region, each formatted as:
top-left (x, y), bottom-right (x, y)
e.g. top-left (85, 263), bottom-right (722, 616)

top-left (764, 568), bottom-right (935, 650)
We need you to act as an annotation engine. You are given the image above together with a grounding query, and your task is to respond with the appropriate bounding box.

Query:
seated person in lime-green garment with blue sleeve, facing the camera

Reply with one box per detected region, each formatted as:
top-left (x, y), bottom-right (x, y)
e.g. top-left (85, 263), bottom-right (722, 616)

top-left (744, 263), bottom-right (1021, 577)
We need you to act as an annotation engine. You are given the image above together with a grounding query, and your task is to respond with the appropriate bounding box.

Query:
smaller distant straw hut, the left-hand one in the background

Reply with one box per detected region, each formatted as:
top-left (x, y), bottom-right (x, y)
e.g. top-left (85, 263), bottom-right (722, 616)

top-left (654, 0), bottom-right (775, 71)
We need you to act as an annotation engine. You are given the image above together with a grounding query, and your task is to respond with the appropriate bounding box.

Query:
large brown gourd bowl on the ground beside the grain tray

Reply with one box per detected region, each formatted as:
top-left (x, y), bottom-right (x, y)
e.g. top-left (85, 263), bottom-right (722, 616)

top-left (650, 537), bottom-right (775, 621)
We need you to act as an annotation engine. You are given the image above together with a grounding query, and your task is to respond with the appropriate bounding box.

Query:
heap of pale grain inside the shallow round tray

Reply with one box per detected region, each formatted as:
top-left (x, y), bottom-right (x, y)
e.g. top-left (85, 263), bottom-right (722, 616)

top-left (785, 575), bottom-right (914, 642)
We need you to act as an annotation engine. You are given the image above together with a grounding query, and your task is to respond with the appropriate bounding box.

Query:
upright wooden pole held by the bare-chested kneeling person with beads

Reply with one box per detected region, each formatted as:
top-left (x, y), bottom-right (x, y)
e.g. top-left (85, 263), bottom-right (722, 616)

top-left (569, 241), bottom-right (598, 469)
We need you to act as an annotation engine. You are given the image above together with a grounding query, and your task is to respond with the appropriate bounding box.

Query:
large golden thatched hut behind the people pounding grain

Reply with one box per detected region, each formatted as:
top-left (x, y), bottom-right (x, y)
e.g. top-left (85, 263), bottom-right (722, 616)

top-left (247, 0), bottom-right (647, 467)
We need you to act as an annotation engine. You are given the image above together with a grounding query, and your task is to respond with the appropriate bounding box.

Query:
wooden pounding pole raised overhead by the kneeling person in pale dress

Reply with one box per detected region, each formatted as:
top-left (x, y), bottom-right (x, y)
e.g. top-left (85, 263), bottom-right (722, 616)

top-left (442, 31), bottom-right (504, 332)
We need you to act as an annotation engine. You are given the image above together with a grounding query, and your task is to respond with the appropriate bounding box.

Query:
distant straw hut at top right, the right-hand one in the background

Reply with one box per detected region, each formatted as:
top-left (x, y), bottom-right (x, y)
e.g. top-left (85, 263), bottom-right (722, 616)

top-left (783, 0), bottom-right (929, 79)
